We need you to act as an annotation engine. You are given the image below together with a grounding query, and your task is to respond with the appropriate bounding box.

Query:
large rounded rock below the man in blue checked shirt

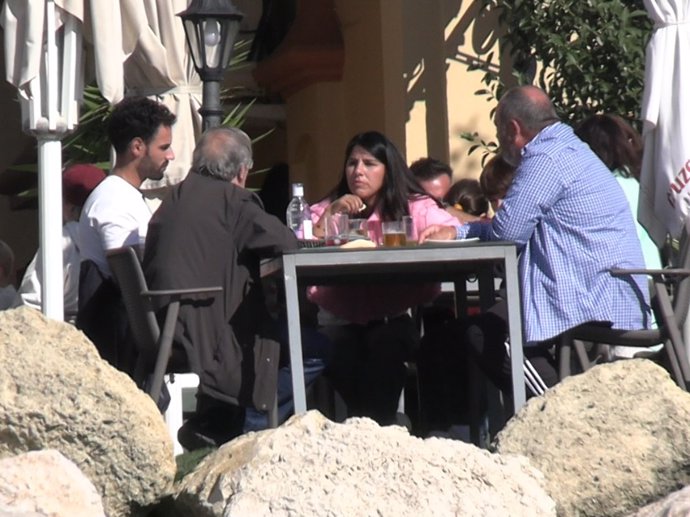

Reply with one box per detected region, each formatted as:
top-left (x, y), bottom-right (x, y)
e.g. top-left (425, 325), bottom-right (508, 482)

top-left (496, 359), bottom-right (690, 517)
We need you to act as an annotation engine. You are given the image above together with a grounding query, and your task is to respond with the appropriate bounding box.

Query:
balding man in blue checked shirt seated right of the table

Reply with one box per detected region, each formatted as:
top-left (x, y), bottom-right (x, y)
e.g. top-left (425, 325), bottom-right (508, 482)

top-left (420, 86), bottom-right (651, 388)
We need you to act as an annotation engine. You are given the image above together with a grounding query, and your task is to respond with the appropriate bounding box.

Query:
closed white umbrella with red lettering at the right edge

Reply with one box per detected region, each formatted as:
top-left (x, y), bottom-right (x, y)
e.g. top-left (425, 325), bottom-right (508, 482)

top-left (638, 0), bottom-right (690, 245)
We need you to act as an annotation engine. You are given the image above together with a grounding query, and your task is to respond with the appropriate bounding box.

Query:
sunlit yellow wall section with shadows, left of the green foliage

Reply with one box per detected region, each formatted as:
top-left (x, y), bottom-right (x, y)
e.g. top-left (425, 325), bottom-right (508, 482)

top-left (403, 0), bottom-right (498, 179)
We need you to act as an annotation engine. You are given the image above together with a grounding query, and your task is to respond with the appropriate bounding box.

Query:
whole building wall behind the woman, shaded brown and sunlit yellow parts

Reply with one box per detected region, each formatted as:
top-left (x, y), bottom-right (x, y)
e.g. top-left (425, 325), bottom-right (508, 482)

top-left (267, 0), bottom-right (497, 202)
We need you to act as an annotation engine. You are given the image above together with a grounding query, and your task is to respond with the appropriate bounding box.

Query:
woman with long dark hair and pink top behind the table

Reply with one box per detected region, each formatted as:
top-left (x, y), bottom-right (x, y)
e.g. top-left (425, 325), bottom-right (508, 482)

top-left (308, 131), bottom-right (456, 425)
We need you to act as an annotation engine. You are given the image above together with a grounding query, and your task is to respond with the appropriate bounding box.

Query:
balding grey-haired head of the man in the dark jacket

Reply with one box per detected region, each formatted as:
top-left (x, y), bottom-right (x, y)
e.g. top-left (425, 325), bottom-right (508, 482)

top-left (191, 127), bottom-right (253, 186)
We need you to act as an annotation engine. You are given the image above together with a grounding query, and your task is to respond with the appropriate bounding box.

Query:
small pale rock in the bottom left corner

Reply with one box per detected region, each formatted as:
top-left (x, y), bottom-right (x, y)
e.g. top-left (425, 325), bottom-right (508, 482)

top-left (0, 450), bottom-right (105, 517)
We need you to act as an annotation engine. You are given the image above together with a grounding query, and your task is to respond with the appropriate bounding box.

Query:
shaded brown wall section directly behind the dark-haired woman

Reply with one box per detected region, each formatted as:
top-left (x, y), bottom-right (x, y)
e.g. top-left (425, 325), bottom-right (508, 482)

top-left (286, 0), bottom-right (406, 202)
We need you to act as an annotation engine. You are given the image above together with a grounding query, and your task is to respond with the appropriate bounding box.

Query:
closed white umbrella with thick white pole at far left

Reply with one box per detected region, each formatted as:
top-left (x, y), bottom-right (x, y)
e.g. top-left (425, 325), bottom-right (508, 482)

top-left (0, 0), bottom-right (84, 320)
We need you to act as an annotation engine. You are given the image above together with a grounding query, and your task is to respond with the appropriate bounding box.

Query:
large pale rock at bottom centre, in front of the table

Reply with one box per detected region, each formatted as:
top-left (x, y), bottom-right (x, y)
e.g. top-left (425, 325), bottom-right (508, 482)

top-left (176, 411), bottom-right (555, 517)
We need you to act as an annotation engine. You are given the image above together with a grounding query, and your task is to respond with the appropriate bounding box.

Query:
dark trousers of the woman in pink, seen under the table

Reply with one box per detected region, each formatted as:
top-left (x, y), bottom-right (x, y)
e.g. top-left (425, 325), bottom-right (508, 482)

top-left (321, 315), bottom-right (419, 425)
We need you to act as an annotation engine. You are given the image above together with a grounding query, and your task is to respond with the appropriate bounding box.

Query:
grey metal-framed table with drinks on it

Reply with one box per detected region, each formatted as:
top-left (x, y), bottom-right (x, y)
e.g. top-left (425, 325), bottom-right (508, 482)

top-left (261, 241), bottom-right (525, 413)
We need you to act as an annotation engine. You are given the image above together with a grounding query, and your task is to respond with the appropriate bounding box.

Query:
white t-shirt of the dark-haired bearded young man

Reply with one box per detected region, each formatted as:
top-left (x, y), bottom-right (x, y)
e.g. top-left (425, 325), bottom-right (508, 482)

top-left (79, 176), bottom-right (151, 276)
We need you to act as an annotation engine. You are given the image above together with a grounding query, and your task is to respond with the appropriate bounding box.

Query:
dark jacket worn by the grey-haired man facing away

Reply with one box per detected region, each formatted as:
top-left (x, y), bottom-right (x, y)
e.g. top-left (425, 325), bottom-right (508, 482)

top-left (144, 173), bottom-right (297, 410)
